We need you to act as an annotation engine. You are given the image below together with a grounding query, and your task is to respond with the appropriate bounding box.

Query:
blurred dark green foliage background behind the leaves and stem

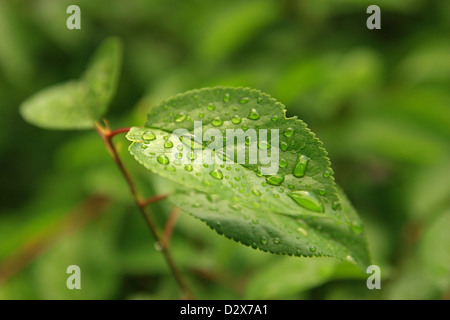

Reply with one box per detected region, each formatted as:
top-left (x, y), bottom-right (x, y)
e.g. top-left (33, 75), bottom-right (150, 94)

top-left (0, 0), bottom-right (450, 299)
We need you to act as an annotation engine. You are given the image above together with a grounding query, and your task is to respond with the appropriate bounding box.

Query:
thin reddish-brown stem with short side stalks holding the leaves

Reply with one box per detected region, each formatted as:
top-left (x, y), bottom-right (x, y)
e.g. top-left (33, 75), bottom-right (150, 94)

top-left (96, 122), bottom-right (193, 299)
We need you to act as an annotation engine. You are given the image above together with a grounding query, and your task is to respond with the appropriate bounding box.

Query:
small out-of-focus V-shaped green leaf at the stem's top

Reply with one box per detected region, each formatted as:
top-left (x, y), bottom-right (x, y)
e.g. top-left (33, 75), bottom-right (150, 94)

top-left (20, 38), bottom-right (122, 129)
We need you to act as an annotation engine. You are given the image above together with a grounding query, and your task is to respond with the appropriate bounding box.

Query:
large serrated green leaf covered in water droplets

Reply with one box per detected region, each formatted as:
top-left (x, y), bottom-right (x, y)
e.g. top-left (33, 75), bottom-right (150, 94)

top-left (127, 87), bottom-right (370, 270)
